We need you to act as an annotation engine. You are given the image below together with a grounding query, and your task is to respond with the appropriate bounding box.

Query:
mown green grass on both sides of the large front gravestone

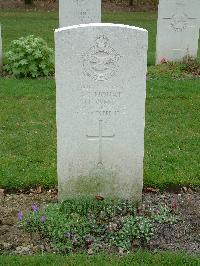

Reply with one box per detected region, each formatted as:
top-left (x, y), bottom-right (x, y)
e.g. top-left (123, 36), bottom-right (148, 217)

top-left (0, 78), bottom-right (200, 188)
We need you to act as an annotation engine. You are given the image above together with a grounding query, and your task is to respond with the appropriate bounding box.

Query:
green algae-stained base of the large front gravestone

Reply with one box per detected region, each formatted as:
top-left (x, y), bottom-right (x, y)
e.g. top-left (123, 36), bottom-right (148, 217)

top-left (58, 166), bottom-right (143, 202)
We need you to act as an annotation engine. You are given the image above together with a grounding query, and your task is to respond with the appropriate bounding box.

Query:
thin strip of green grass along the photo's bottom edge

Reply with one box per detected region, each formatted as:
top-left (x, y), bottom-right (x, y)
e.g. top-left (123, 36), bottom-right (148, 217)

top-left (0, 252), bottom-right (200, 266)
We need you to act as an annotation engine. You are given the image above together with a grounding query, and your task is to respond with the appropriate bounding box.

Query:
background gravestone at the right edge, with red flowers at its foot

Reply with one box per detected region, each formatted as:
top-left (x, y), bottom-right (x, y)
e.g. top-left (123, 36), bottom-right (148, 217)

top-left (156, 0), bottom-right (200, 64)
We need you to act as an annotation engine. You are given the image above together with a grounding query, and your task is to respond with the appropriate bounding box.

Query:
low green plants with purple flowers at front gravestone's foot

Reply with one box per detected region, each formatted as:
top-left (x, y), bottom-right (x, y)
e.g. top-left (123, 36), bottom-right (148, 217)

top-left (18, 198), bottom-right (176, 253)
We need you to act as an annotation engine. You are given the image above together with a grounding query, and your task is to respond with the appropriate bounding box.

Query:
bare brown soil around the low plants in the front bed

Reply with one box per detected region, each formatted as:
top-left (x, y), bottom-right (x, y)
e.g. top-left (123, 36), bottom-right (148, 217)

top-left (0, 189), bottom-right (200, 254)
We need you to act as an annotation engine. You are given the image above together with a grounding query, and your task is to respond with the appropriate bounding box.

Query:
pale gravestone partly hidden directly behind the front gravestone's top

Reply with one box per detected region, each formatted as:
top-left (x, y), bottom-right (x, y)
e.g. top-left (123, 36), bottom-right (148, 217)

top-left (59, 0), bottom-right (101, 27)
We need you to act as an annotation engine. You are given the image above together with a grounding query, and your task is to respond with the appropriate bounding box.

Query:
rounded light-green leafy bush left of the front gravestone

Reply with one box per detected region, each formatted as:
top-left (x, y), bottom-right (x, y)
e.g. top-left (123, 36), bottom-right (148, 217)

top-left (5, 35), bottom-right (54, 78)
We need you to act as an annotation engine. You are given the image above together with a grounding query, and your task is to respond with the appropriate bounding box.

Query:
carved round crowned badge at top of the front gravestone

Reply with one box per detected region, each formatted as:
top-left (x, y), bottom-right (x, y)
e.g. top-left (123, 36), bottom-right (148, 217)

top-left (83, 35), bottom-right (121, 81)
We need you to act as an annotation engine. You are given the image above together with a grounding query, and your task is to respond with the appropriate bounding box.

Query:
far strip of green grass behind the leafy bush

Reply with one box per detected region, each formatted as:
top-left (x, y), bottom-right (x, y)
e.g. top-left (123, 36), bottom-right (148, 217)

top-left (0, 10), bottom-right (200, 65)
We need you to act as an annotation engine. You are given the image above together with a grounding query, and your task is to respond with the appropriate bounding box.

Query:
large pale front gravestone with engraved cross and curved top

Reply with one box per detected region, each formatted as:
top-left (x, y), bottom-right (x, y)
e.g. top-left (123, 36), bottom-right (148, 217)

top-left (55, 24), bottom-right (148, 201)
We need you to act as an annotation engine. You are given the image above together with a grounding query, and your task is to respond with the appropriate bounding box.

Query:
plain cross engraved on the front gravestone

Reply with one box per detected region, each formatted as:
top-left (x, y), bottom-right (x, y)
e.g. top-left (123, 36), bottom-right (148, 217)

top-left (86, 120), bottom-right (115, 165)
